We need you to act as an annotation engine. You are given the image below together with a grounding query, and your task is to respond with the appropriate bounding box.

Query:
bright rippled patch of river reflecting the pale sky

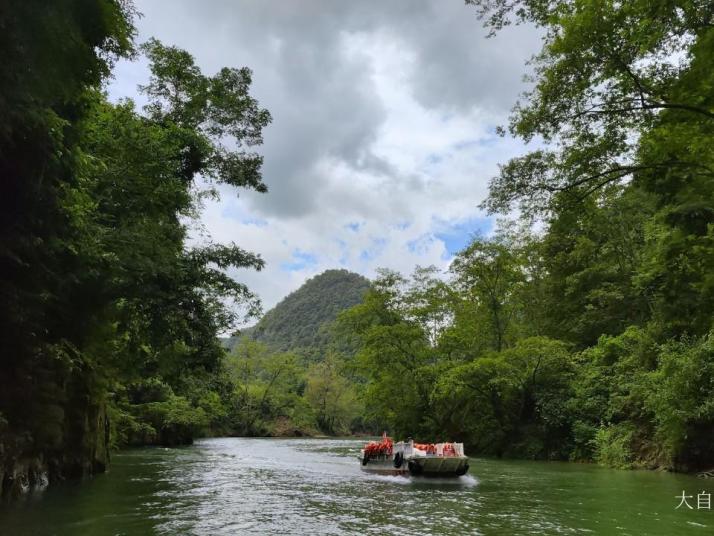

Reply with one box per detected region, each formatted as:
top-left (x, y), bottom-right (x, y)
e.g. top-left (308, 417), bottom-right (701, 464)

top-left (151, 439), bottom-right (484, 534)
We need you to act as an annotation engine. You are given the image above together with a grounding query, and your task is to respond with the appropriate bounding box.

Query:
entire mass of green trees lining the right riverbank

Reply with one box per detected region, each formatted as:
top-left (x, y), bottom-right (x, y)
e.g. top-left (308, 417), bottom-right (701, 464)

top-left (340, 0), bottom-right (714, 470)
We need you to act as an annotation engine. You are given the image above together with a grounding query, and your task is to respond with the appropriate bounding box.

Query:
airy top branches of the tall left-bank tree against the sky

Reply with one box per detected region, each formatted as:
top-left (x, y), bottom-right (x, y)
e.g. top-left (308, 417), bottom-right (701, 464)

top-left (141, 39), bottom-right (271, 192)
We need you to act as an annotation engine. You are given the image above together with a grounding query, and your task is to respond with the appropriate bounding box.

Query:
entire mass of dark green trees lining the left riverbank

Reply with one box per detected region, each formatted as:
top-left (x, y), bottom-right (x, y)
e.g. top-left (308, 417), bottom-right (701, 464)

top-left (0, 0), bottom-right (270, 490)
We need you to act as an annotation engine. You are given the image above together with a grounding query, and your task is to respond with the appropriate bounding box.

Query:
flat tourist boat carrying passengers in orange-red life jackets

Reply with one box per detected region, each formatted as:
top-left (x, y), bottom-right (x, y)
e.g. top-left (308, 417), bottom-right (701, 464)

top-left (359, 434), bottom-right (469, 477)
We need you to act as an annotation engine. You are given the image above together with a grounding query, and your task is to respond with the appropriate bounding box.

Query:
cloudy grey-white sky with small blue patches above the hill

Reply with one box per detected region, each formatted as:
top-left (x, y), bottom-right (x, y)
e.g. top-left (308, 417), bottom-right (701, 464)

top-left (109, 0), bottom-right (540, 316)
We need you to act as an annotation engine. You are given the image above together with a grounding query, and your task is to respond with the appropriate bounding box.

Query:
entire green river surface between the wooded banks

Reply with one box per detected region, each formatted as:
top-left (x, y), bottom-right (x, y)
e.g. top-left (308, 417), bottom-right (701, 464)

top-left (0, 438), bottom-right (714, 536)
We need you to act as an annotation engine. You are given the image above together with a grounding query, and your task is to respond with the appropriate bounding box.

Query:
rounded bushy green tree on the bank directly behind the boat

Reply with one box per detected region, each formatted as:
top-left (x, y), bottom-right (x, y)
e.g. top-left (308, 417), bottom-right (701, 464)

top-left (434, 337), bottom-right (574, 459)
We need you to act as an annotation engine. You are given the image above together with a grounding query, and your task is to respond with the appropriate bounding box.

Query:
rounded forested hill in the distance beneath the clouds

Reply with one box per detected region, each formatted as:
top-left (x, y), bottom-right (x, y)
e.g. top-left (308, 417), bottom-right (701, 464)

top-left (231, 270), bottom-right (370, 353)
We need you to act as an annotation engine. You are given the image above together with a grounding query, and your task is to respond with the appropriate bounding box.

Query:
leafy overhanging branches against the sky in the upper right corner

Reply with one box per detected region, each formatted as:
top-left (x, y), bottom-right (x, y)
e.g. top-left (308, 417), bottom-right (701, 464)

top-left (467, 0), bottom-right (714, 218)
